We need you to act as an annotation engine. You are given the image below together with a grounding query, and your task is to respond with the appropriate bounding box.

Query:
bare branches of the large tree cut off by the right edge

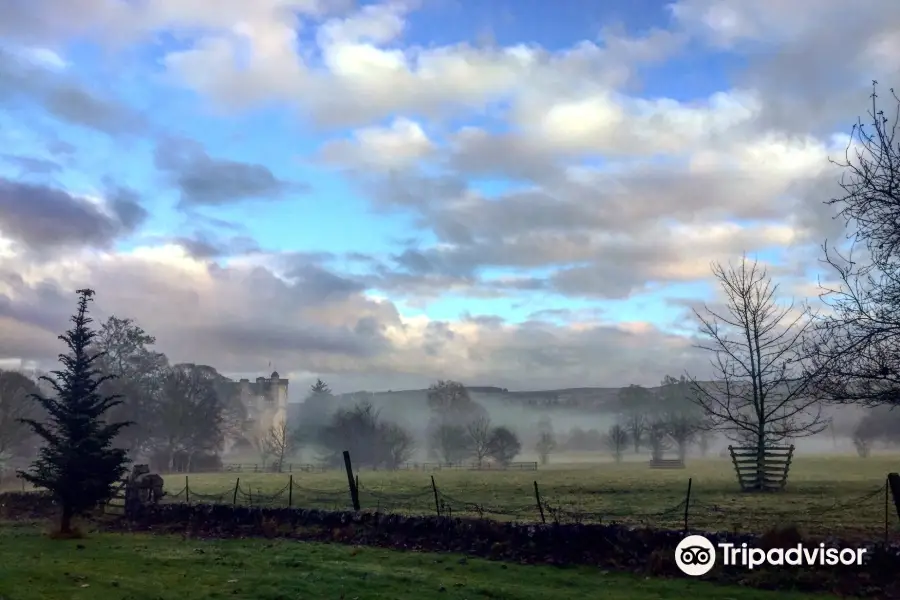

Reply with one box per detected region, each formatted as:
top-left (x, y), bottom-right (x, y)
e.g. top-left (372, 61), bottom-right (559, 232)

top-left (806, 82), bottom-right (900, 406)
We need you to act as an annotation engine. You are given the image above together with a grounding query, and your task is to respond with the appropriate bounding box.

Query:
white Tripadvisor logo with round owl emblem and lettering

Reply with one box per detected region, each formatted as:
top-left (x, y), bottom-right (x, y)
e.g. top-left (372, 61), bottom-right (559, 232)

top-left (675, 535), bottom-right (866, 577)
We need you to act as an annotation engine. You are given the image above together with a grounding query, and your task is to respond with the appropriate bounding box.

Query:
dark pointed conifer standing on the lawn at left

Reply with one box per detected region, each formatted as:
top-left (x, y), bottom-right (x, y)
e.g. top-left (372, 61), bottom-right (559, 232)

top-left (20, 289), bottom-right (131, 534)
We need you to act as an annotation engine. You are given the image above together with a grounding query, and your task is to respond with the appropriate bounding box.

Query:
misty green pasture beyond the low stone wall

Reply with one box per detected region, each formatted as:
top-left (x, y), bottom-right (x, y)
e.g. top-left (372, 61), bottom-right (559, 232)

top-left (166, 455), bottom-right (900, 538)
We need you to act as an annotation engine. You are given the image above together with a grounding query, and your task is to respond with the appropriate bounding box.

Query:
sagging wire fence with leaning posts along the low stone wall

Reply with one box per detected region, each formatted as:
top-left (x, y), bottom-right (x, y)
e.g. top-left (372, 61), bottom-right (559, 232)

top-left (119, 475), bottom-right (900, 542)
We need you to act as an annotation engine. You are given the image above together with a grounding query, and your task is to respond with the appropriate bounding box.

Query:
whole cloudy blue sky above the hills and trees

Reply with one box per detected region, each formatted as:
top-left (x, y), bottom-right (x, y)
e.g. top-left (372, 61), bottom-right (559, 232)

top-left (0, 0), bottom-right (900, 395)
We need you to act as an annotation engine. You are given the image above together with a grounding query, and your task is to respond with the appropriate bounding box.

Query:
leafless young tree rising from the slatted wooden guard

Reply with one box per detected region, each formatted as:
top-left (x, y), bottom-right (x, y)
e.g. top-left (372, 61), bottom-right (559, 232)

top-left (691, 257), bottom-right (828, 486)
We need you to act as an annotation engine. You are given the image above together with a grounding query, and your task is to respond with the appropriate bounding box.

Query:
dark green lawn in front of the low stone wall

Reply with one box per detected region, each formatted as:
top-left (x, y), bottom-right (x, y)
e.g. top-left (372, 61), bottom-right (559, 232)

top-left (0, 524), bottom-right (824, 600)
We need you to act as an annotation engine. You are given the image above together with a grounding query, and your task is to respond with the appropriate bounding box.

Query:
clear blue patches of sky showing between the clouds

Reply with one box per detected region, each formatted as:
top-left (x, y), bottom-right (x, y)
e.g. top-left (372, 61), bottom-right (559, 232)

top-left (7, 1), bottom-right (733, 326)
